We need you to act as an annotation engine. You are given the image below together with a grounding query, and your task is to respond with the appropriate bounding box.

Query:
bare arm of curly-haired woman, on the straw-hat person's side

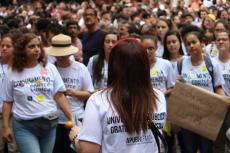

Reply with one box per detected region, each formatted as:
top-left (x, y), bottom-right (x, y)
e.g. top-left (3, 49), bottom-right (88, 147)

top-left (54, 92), bottom-right (72, 121)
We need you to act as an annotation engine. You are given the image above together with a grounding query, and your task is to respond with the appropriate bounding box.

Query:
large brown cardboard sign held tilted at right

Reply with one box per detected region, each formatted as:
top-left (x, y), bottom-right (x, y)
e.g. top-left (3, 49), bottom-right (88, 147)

top-left (168, 82), bottom-right (229, 141)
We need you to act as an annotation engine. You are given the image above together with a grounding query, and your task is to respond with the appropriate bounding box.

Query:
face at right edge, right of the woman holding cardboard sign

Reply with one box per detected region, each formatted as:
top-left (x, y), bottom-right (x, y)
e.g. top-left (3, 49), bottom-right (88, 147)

top-left (216, 32), bottom-right (230, 52)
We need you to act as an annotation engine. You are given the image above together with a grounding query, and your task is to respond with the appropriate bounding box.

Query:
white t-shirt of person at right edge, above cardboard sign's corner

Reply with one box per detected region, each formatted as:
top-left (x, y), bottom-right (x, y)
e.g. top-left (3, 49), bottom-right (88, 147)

top-left (216, 59), bottom-right (230, 96)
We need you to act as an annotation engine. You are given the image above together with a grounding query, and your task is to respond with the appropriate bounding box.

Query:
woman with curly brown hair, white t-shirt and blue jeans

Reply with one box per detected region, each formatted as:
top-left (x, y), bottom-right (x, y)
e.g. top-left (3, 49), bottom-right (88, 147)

top-left (3, 33), bottom-right (72, 153)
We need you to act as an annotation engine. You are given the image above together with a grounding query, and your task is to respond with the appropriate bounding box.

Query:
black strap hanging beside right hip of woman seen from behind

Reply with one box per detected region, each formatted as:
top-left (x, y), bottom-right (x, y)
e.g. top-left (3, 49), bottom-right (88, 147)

top-left (149, 122), bottom-right (168, 153)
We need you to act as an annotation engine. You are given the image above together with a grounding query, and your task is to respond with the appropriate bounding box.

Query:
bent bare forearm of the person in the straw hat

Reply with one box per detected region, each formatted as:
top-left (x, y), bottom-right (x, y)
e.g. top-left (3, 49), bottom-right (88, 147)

top-left (65, 88), bottom-right (91, 100)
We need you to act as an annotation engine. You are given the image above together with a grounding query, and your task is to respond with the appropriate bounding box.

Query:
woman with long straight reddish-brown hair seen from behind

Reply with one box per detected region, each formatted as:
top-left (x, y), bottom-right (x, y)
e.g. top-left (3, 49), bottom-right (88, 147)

top-left (70, 38), bottom-right (166, 153)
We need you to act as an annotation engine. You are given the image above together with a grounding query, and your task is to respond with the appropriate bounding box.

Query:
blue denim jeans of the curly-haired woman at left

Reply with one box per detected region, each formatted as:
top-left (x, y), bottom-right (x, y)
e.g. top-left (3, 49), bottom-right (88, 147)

top-left (13, 118), bottom-right (56, 153)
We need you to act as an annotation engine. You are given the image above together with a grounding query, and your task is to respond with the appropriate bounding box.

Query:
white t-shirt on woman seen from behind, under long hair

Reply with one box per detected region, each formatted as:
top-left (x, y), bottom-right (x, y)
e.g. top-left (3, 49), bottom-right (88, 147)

top-left (78, 89), bottom-right (166, 153)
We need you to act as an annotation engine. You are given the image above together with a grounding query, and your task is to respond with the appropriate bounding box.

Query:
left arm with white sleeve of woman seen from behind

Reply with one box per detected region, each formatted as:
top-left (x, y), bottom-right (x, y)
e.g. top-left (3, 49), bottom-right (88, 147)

top-left (69, 95), bottom-right (103, 153)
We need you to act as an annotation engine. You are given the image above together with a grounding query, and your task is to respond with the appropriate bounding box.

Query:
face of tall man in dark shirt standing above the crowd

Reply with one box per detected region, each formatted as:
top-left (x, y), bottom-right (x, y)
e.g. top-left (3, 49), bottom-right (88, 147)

top-left (83, 9), bottom-right (97, 27)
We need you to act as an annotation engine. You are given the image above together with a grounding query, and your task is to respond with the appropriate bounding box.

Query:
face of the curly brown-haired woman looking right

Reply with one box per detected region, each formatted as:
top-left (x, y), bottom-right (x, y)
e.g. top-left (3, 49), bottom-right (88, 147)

top-left (25, 38), bottom-right (41, 60)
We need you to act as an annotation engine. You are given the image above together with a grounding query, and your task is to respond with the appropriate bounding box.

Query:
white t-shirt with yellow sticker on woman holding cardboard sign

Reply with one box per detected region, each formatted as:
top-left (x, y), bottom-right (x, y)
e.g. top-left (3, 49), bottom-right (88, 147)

top-left (177, 56), bottom-right (224, 92)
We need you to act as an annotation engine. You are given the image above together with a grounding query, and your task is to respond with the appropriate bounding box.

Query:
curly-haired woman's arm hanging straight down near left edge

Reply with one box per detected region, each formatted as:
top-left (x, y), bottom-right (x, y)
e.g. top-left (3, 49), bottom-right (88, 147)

top-left (2, 101), bottom-right (13, 142)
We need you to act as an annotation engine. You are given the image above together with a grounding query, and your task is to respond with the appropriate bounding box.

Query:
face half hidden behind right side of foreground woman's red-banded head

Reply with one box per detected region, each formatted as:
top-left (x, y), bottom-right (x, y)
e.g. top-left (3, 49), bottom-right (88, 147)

top-left (142, 39), bottom-right (156, 60)
